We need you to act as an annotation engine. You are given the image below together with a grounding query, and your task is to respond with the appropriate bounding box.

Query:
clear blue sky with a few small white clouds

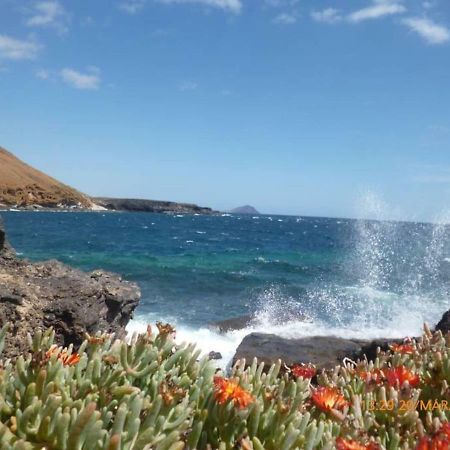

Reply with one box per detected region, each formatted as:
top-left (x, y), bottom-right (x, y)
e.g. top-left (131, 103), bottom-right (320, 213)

top-left (0, 0), bottom-right (450, 220)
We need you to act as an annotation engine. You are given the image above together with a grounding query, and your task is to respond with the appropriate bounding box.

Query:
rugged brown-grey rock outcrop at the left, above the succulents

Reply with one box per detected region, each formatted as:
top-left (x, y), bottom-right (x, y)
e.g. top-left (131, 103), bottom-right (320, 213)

top-left (0, 219), bottom-right (141, 357)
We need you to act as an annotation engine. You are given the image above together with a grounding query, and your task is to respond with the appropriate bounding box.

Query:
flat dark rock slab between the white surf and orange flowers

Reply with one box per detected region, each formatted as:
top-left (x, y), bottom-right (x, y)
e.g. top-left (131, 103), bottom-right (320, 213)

top-left (233, 333), bottom-right (399, 369)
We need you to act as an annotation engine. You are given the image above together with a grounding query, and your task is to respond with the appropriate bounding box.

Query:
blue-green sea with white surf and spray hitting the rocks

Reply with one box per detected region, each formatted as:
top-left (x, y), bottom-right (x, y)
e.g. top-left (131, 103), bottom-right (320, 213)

top-left (1, 212), bottom-right (450, 366)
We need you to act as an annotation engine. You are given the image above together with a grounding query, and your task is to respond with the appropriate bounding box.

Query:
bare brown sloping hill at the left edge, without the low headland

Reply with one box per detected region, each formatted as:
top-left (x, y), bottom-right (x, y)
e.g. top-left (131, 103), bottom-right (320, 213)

top-left (0, 147), bottom-right (92, 208)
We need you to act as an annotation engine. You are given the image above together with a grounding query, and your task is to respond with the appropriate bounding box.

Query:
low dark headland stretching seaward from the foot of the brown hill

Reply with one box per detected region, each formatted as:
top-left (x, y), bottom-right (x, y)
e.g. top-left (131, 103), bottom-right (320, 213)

top-left (93, 197), bottom-right (214, 214)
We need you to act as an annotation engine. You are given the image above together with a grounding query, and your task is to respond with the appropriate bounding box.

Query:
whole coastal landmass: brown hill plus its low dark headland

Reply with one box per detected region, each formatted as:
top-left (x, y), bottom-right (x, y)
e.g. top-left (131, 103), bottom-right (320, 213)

top-left (0, 147), bottom-right (216, 214)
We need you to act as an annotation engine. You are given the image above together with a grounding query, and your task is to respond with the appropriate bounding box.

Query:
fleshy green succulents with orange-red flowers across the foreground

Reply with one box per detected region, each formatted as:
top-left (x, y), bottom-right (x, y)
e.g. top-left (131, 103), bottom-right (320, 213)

top-left (0, 324), bottom-right (450, 450)
